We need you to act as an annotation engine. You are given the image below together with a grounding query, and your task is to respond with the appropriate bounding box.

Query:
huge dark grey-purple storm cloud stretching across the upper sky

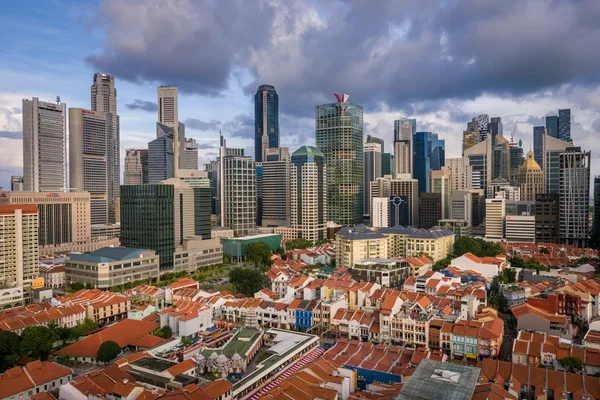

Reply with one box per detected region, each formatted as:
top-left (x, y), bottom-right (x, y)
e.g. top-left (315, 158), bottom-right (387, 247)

top-left (87, 0), bottom-right (600, 118)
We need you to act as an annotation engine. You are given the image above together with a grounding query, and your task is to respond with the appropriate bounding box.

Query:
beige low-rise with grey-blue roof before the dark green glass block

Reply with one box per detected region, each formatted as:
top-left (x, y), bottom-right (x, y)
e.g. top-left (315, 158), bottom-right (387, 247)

top-left (65, 247), bottom-right (160, 289)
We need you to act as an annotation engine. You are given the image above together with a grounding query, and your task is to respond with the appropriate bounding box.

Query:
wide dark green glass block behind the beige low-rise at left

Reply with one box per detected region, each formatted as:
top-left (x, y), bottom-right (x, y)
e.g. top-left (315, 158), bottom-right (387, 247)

top-left (121, 185), bottom-right (175, 271)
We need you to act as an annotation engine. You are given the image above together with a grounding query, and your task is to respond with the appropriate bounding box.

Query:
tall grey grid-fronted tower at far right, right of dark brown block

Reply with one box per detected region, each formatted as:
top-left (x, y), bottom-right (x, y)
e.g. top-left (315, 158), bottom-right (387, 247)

top-left (559, 147), bottom-right (590, 247)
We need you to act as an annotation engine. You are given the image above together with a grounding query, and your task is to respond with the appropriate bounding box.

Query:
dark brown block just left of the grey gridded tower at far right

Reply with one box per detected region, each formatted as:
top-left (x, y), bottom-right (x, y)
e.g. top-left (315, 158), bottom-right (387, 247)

top-left (535, 193), bottom-right (560, 243)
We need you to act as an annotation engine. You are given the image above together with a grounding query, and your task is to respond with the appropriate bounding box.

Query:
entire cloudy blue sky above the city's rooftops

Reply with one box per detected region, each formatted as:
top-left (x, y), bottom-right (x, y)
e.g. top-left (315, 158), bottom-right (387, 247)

top-left (0, 0), bottom-right (600, 188)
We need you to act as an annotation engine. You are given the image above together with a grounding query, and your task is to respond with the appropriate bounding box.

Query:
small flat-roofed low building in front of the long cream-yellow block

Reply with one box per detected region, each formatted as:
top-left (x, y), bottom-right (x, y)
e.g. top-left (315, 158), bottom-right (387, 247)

top-left (351, 258), bottom-right (410, 288)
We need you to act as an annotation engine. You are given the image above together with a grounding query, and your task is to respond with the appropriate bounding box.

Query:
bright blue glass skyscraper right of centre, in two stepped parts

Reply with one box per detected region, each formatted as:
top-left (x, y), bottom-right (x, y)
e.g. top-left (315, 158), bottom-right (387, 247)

top-left (413, 132), bottom-right (445, 192)
